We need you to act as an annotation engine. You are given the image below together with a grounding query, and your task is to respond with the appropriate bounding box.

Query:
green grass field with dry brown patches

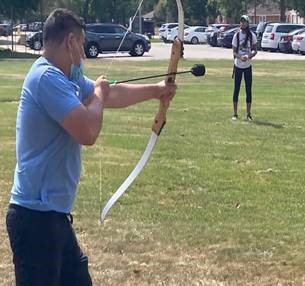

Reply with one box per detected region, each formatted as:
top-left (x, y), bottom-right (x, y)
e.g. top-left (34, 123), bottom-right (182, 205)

top-left (0, 59), bottom-right (305, 286)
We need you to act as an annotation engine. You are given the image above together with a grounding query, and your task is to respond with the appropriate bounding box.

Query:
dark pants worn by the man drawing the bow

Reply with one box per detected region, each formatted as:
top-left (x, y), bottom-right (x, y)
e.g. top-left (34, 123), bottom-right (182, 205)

top-left (6, 205), bottom-right (92, 286)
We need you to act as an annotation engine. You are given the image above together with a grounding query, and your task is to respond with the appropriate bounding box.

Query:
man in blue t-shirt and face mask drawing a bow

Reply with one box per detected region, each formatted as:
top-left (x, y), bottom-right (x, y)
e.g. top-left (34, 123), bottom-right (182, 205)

top-left (7, 9), bottom-right (176, 286)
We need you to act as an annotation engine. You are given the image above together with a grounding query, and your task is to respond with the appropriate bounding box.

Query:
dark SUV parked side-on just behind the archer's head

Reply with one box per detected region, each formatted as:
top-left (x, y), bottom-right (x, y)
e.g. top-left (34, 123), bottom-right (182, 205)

top-left (85, 24), bottom-right (151, 58)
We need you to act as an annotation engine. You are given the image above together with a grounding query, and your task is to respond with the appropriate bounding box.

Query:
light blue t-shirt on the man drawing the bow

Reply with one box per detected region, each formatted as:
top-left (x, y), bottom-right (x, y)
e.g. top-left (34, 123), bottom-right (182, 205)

top-left (10, 57), bottom-right (94, 213)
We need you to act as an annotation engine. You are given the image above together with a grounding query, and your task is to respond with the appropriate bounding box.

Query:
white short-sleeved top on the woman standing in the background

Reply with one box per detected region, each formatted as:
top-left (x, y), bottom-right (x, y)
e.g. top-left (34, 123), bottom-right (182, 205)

top-left (232, 29), bottom-right (257, 69)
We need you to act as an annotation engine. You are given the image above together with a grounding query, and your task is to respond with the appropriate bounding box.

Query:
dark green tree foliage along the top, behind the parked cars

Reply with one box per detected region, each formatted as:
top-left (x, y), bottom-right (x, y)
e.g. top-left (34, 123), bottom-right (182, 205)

top-left (0, 0), bottom-right (305, 25)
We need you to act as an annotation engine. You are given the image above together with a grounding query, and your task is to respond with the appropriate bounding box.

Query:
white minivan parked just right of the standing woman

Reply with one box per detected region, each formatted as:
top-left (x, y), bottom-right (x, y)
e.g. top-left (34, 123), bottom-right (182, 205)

top-left (261, 23), bottom-right (305, 51)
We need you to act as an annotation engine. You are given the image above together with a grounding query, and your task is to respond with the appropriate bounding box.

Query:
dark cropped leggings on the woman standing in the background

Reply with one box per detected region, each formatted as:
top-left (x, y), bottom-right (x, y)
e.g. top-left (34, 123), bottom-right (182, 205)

top-left (233, 66), bottom-right (252, 103)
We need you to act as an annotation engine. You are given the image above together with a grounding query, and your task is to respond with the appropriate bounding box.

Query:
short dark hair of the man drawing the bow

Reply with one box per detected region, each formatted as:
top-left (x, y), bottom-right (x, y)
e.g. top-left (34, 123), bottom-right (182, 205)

top-left (43, 8), bottom-right (85, 43)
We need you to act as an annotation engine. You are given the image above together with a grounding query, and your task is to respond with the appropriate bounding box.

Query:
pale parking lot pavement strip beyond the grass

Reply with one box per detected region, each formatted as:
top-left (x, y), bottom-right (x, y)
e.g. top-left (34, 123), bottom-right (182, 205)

top-left (0, 37), bottom-right (305, 60)
